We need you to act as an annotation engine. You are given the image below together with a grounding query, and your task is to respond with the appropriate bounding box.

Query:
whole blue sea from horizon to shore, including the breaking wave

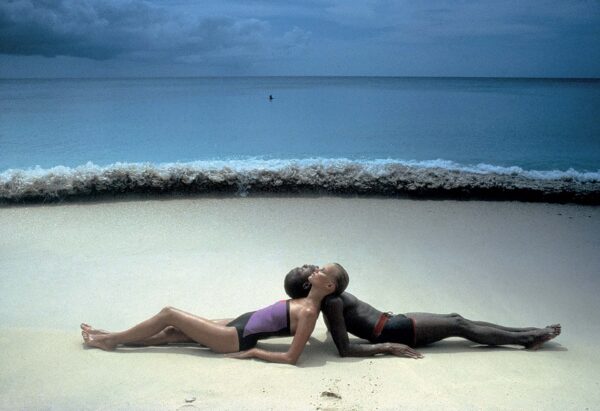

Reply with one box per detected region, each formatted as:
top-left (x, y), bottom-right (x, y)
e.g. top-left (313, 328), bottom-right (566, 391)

top-left (0, 77), bottom-right (600, 204)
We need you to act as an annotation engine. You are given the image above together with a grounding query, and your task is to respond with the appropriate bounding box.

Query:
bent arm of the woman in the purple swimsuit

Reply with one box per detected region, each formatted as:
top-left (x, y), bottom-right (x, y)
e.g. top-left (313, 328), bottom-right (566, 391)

top-left (230, 308), bottom-right (319, 365)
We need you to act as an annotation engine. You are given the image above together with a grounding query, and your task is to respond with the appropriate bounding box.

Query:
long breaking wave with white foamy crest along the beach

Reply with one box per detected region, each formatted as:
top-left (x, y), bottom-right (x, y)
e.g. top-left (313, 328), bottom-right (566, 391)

top-left (0, 158), bottom-right (600, 204)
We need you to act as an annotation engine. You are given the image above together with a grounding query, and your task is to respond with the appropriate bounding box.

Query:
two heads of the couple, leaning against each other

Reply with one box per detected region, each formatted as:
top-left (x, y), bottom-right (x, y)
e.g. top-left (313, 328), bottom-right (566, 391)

top-left (284, 263), bottom-right (350, 298)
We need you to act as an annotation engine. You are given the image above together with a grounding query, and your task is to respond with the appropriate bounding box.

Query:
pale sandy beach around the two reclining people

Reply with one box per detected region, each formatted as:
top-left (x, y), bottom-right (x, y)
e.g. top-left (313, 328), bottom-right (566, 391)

top-left (0, 197), bottom-right (600, 410)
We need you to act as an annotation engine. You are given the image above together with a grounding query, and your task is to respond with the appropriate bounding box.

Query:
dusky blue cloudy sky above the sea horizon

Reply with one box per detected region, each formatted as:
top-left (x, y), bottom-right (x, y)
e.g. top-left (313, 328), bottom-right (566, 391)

top-left (0, 0), bottom-right (600, 78)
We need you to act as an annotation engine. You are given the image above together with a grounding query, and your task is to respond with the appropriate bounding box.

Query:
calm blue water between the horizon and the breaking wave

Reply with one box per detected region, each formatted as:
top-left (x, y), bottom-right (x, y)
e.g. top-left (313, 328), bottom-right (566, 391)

top-left (0, 77), bottom-right (600, 171)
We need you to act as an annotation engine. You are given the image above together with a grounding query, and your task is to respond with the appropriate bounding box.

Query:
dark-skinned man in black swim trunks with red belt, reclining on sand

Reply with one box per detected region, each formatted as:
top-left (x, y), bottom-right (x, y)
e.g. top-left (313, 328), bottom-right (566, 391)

top-left (284, 265), bottom-right (561, 358)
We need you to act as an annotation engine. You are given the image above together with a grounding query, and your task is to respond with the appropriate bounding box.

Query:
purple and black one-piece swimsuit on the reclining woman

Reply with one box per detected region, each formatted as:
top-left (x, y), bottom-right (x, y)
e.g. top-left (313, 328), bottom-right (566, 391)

top-left (227, 300), bottom-right (291, 351)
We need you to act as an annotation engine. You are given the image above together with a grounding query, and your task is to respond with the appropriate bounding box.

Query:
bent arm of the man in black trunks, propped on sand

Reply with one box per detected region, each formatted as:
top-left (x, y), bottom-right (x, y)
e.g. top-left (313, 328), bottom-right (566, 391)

top-left (322, 297), bottom-right (422, 358)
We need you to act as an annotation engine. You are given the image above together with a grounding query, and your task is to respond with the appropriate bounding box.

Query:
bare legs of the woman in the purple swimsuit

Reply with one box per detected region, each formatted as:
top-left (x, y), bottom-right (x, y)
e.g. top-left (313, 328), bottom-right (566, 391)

top-left (82, 307), bottom-right (239, 353)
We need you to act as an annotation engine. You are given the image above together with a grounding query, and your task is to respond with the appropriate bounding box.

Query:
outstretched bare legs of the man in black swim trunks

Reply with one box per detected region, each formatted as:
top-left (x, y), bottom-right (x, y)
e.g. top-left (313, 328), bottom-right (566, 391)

top-left (405, 313), bottom-right (561, 349)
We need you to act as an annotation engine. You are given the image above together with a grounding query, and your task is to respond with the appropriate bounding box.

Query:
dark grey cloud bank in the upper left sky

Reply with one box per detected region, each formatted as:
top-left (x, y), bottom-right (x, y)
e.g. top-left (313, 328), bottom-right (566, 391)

top-left (0, 0), bottom-right (308, 66)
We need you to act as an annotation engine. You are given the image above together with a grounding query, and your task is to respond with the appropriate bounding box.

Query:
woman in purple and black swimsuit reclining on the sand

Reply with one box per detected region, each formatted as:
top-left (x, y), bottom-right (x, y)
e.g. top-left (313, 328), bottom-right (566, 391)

top-left (81, 263), bottom-right (348, 364)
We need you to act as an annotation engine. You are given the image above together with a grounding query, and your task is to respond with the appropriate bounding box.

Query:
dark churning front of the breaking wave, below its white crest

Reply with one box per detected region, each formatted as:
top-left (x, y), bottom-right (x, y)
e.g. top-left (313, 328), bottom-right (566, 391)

top-left (0, 165), bottom-right (600, 205)
